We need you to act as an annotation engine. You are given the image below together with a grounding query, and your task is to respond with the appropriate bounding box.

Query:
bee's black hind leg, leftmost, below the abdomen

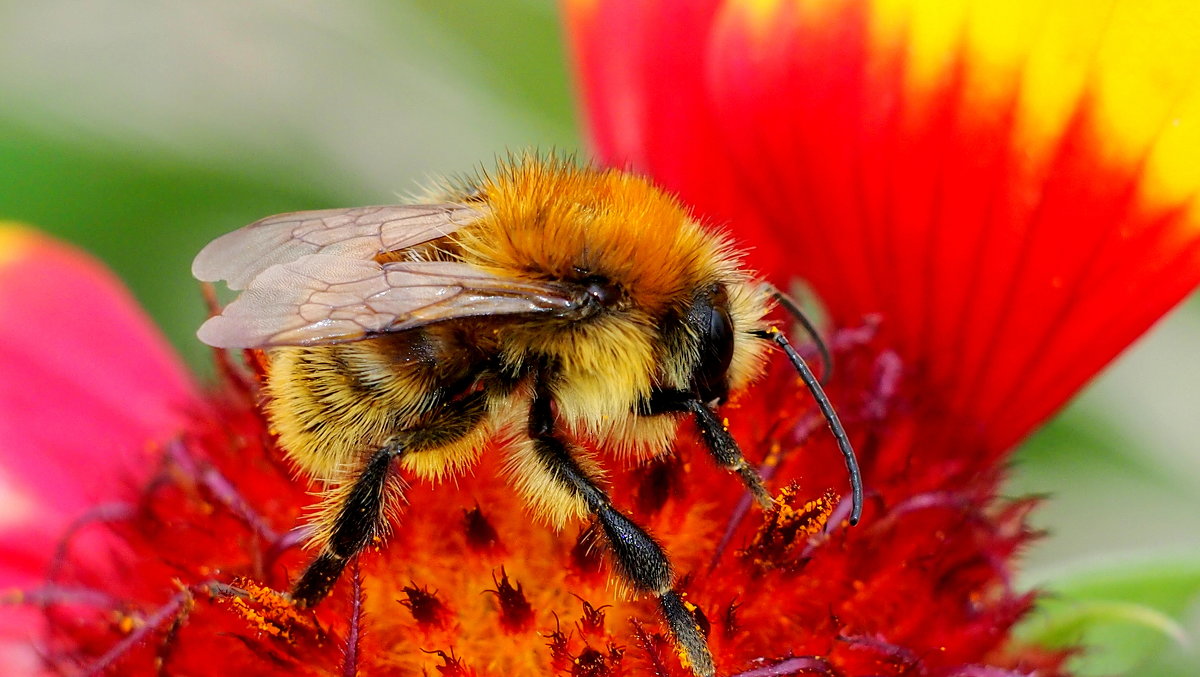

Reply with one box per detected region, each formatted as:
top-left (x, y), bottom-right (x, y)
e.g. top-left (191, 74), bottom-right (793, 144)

top-left (292, 442), bottom-right (401, 606)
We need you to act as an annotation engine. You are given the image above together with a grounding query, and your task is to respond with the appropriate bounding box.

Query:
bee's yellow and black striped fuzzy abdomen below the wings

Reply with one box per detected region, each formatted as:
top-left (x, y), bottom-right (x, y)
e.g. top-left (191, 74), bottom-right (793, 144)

top-left (266, 328), bottom-right (486, 480)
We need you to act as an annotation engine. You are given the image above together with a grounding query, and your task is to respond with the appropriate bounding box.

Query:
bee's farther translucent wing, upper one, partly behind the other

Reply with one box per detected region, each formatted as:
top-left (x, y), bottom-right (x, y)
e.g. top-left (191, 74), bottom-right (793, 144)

top-left (192, 204), bottom-right (484, 289)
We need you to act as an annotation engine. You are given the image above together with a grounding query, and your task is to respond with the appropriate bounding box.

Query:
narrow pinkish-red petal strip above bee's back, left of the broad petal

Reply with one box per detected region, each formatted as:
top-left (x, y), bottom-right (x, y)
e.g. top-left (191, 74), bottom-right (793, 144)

top-left (565, 0), bottom-right (782, 271)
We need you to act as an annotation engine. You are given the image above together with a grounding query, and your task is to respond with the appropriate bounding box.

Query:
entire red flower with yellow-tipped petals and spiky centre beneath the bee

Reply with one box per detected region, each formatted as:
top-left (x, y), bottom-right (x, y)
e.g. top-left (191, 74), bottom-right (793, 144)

top-left (0, 0), bottom-right (1200, 677)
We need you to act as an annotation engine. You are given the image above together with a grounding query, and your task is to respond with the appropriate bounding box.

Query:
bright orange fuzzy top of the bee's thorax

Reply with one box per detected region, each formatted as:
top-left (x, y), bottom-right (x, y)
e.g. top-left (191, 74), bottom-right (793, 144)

top-left (455, 161), bottom-right (737, 313)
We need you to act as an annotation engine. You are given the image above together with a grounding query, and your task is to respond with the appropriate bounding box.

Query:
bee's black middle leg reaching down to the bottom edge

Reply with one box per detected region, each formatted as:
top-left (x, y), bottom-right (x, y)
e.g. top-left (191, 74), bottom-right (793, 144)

top-left (529, 383), bottom-right (716, 677)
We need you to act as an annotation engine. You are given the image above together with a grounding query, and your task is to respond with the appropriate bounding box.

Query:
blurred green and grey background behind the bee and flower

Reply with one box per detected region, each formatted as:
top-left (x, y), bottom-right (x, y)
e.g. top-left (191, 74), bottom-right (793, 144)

top-left (0, 0), bottom-right (1200, 676)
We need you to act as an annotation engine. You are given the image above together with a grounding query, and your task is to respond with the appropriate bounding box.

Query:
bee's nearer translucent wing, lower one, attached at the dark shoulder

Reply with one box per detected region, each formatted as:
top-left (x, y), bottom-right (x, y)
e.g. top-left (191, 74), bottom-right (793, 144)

top-left (197, 253), bottom-right (587, 348)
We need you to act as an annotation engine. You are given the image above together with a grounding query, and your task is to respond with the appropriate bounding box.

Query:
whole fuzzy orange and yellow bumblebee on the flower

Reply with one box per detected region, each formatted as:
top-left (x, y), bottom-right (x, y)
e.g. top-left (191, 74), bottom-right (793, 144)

top-left (192, 157), bottom-right (862, 676)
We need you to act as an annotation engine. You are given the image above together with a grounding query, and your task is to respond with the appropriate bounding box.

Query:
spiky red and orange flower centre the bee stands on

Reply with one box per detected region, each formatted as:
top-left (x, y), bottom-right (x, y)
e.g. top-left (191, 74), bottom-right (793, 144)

top-left (0, 223), bottom-right (1061, 677)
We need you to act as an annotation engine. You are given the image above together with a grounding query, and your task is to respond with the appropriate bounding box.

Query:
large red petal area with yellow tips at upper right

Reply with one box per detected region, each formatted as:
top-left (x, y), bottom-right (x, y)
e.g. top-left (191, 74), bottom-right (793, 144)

top-left (569, 0), bottom-right (1200, 453)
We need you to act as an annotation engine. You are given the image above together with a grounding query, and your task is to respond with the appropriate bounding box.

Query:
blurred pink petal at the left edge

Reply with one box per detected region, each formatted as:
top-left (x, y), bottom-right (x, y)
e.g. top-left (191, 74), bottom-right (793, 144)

top-left (0, 223), bottom-right (196, 675)
